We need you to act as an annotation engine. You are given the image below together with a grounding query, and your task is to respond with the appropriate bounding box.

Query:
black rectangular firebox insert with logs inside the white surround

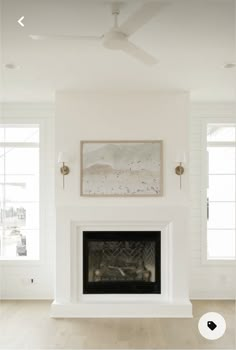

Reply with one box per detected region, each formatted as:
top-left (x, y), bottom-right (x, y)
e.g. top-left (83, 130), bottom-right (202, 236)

top-left (83, 231), bottom-right (161, 294)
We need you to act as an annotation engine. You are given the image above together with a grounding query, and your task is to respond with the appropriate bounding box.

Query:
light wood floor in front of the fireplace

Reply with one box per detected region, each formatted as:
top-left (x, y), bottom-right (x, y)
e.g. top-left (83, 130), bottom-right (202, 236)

top-left (0, 301), bottom-right (236, 349)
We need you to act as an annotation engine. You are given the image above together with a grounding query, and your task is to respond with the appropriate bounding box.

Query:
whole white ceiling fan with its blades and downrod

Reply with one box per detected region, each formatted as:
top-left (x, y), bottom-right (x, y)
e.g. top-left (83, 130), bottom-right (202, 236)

top-left (29, 1), bottom-right (163, 65)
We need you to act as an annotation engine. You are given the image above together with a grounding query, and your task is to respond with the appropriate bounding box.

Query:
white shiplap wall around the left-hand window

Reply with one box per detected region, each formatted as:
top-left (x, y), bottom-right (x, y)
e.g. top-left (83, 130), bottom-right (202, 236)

top-left (0, 103), bottom-right (55, 299)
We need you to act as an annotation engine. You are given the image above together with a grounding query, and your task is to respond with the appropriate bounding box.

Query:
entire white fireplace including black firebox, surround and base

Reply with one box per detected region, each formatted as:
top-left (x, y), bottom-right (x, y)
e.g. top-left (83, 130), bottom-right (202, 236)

top-left (51, 219), bottom-right (192, 318)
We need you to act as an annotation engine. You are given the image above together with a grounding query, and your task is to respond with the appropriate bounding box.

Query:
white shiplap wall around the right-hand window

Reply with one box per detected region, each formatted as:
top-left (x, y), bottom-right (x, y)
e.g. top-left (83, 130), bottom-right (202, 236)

top-left (190, 103), bottom-right (236, 299)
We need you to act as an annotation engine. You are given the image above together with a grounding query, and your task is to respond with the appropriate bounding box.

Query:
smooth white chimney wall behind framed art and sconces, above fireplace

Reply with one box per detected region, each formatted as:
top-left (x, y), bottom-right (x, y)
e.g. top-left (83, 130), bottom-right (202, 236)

top-left (56, 92), bottom-right (189, 205)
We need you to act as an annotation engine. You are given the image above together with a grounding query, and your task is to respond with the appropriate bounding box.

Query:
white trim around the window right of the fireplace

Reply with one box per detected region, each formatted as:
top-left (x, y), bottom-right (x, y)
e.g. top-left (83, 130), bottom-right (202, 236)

top-left (200, 116), bottom-right (236, 267)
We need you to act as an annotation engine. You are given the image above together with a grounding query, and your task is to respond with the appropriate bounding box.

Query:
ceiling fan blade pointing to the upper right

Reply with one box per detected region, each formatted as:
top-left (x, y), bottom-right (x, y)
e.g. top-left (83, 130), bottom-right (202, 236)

top-left (120, 1), bottom-right (165, 35)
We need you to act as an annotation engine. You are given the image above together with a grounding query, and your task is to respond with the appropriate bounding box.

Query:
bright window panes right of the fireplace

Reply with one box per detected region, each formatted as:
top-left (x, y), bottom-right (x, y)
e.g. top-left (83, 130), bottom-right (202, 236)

top-left (207, 124), bottom-right (236, 260)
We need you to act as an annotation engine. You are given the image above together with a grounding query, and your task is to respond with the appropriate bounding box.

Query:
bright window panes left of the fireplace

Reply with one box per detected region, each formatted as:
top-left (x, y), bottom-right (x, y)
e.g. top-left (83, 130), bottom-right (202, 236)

top-left (0, 124), bottom-right (40, 259)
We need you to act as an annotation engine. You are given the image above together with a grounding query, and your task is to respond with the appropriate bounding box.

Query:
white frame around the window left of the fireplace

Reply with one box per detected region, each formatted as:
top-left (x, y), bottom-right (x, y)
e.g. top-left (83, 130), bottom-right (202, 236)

top-left (0, 117), bottom-right (47, 266)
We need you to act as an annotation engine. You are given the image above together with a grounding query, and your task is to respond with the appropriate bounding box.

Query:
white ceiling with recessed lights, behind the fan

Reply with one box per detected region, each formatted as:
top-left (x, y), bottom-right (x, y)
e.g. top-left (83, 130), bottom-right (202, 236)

top-left (1, 0), bottom-right (236, 101)
